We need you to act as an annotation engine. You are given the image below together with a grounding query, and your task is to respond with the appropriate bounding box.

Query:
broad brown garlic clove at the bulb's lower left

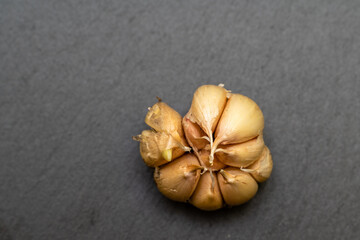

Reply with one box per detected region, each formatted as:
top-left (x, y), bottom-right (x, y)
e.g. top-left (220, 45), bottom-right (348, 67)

top-left (154, 153), bottom-right (202, 202)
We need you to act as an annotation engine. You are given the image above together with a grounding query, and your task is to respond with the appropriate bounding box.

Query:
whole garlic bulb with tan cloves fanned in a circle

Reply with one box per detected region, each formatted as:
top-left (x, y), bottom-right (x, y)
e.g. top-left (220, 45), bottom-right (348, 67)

top-left (133, 84), bottom-right (273, 211)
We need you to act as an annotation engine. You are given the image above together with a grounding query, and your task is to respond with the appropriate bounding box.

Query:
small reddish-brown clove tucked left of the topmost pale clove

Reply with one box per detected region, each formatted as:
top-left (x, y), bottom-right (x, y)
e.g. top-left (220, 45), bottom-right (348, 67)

top-left (182, 114), bottom-right (209, 150)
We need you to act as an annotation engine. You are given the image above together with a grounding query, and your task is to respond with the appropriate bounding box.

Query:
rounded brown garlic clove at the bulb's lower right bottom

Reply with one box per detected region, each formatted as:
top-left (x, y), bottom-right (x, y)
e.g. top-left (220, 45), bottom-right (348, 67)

top-left (217, 167), bottom-right (258, 206)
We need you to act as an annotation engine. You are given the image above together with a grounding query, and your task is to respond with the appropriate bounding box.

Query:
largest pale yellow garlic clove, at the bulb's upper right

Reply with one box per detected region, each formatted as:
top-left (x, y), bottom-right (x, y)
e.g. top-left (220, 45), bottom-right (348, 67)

top-left (214, 94), bottom-right (264, 146)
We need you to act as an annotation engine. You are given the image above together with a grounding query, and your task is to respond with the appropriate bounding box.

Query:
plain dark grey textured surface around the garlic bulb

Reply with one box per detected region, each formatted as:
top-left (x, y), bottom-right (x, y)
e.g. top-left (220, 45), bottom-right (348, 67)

top-left (0, 0), bottom-right (360, 239)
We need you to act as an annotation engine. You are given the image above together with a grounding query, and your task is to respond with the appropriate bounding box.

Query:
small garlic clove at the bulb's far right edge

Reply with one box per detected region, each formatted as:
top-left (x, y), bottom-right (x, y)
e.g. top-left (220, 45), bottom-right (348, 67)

top-left (247, 146), bottom-right (273, 182)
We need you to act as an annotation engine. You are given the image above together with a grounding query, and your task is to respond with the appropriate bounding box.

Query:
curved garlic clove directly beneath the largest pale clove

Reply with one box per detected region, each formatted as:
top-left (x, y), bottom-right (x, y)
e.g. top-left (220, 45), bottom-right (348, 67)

top-left (215, 134), bottom-right (265, 167)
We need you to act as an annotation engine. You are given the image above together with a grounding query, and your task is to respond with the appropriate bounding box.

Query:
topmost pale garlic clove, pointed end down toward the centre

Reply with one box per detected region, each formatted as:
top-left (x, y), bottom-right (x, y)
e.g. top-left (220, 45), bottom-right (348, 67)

top-left (188, 85), bottom-right (227, 138)
